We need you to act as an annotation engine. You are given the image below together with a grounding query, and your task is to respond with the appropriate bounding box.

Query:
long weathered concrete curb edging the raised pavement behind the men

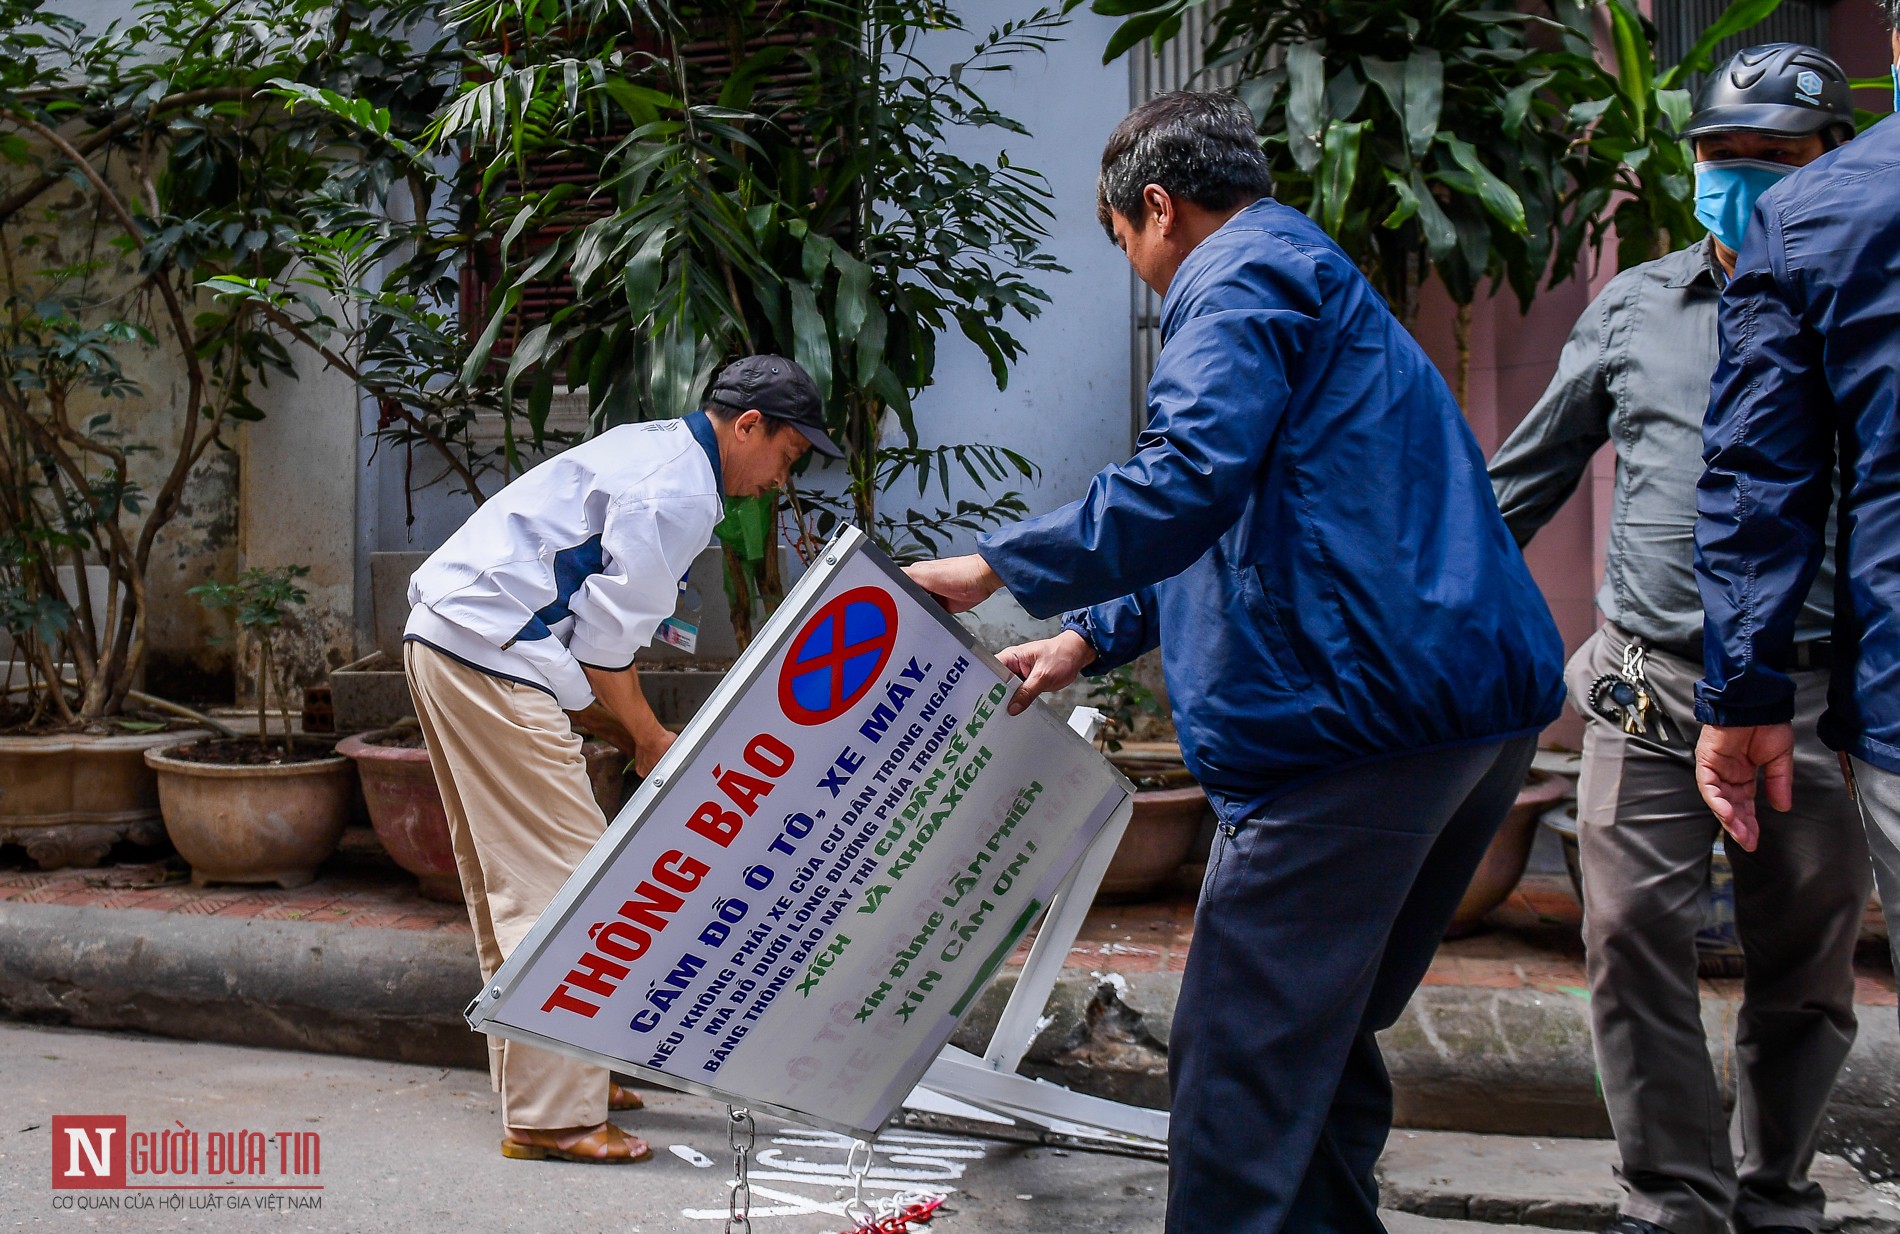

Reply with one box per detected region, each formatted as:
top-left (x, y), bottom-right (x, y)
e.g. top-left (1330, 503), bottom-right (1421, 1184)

top-left (0, 903), bottom-right (1900, 1178)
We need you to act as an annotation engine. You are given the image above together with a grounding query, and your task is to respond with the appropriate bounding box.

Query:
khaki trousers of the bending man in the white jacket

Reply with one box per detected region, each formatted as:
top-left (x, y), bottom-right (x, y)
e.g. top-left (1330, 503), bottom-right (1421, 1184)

top-left (403, 643), bottom-right (608, 1129)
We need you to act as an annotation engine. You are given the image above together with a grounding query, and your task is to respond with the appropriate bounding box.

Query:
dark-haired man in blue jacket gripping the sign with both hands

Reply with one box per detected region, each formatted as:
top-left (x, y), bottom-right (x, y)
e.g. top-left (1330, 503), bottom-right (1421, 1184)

top-left (910, 93), bottom-right (1564, 1234)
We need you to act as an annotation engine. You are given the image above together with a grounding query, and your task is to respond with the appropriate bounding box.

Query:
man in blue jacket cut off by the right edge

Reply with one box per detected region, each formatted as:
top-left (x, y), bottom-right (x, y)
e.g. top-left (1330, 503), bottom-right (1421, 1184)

top-left (1695, 0), bottom-right (1900, 981)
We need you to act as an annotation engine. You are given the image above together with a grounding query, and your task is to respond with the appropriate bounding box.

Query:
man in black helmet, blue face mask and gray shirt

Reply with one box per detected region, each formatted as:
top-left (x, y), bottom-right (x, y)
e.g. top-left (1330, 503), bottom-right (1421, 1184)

top-left (1490, 44), bottom-right (1870, 1234)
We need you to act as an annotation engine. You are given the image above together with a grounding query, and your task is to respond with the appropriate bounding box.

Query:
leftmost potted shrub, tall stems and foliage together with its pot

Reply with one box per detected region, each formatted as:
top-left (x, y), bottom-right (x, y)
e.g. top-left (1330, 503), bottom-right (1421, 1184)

top-left (0, 0), bottom-right (462, 865)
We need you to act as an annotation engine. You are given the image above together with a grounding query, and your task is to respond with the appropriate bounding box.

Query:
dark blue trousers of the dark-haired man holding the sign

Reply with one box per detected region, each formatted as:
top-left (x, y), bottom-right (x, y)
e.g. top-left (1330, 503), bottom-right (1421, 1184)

top-left (1167, 738), bottom-right (1537, 1234)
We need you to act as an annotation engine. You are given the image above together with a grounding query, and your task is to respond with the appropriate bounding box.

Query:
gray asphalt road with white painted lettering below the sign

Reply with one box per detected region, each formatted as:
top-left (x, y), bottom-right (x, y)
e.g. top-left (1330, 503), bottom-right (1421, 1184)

top-left (0, 1023), bottom-right (1167, 1234)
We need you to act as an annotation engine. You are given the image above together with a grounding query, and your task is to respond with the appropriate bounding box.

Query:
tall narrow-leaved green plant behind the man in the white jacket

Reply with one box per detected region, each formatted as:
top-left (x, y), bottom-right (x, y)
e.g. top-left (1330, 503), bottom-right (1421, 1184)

top-left (406, 0), bottom-right (1064, 595)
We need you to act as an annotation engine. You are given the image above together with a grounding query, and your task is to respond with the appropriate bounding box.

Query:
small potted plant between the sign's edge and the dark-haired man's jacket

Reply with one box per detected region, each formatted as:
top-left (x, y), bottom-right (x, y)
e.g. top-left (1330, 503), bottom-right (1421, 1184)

top-left (1089, 665), bottom-right (1207, 899)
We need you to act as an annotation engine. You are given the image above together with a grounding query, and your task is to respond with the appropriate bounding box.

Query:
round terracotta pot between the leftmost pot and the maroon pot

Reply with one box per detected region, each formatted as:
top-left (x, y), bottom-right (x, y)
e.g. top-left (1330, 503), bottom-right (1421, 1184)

top-left (144, 745), bottom-right (355, 888)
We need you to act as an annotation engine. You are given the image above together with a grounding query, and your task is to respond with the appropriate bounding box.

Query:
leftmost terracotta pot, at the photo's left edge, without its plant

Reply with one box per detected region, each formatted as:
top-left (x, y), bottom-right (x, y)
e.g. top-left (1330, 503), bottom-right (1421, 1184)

top-left (0, 728), bottom-right (205, 869)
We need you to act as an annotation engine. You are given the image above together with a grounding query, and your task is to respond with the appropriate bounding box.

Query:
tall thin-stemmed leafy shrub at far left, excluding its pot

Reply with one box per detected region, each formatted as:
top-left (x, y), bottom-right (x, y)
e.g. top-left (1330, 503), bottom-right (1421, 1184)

top-left (0, 0), bottom-right (462, 724)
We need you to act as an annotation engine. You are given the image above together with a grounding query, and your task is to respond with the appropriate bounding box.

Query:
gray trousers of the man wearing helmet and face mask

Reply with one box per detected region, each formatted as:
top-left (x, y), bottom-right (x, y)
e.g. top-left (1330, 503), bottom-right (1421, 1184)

top-left (1568, 626), bottom-right (1872, 1234)
